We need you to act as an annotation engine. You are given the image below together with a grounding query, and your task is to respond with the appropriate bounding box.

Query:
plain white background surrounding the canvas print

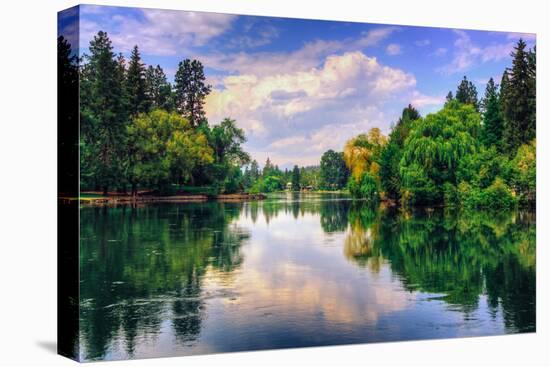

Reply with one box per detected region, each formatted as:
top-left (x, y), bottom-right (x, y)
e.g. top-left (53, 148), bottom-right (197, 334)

top-left (0, 0), bottom-right (550, 367)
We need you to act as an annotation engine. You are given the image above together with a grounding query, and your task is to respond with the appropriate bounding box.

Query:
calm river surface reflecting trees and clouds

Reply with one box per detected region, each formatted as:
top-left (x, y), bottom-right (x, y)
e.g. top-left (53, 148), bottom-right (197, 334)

top-left (79, 194), bottom-right (535, 360)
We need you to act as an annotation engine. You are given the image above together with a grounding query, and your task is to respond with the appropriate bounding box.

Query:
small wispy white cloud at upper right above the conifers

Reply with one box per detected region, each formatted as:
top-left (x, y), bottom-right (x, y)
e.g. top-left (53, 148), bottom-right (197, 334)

top-left (438, 30), bottom-right (514, 74)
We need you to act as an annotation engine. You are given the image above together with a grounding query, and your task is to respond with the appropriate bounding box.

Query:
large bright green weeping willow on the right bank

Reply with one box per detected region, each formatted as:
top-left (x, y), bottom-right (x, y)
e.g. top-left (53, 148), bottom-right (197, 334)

top-left (400, 101), bottom-right (481, 204)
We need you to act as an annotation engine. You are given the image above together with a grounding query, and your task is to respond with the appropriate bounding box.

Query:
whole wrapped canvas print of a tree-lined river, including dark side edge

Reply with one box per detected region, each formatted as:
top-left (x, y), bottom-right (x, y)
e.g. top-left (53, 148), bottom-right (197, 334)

top-left (57, 5), bottom-right (536, 361)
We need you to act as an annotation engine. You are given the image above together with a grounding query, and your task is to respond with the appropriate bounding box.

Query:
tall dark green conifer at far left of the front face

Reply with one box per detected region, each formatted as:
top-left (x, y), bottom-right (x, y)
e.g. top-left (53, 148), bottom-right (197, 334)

top-left (80, 31), bottom-right (128, 194)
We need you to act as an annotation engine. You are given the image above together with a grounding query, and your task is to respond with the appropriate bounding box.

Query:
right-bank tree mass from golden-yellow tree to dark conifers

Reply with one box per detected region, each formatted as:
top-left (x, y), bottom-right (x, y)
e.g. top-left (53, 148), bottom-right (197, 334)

top-left (344, 40), bottom-right (536, 209)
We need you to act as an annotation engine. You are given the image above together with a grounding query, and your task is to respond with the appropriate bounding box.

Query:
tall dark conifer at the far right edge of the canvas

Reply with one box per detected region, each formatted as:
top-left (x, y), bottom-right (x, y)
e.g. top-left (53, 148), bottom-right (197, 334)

top-left (503, 39), bottom-right (536, 152)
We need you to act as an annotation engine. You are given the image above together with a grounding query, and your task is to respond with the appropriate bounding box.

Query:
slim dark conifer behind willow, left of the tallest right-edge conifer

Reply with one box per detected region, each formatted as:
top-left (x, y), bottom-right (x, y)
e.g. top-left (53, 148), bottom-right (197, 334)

top-left (481, 78), bottom-right (504, 149)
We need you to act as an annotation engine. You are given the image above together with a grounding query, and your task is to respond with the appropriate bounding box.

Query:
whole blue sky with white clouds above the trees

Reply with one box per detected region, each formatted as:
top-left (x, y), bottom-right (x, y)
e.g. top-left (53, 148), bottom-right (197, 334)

top-left (59, 5), bottom-right (536, 168)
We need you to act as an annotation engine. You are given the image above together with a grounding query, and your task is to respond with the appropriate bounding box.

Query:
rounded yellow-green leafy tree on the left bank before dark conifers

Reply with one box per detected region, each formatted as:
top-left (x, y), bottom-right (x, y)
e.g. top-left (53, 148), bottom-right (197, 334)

top-left (127, 109), bottom-right (214, 195)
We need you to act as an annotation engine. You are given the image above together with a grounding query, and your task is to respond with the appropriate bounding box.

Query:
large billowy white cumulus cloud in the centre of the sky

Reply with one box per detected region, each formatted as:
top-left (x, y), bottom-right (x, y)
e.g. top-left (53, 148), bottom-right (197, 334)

top-left (206, 51), bottom-right (416, 165)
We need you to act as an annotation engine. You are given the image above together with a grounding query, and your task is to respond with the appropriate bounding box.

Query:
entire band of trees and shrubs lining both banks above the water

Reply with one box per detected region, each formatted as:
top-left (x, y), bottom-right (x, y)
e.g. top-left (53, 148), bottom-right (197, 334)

top-left (58, 31), bottom-right (536, 208)
